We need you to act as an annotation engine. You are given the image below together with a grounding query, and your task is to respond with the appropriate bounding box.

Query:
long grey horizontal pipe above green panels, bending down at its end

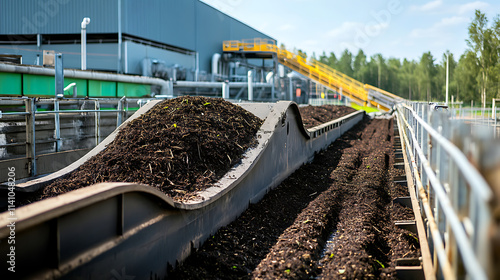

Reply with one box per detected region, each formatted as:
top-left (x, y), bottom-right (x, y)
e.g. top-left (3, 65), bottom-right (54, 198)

top-left (0, 63), bottom-right (174, 96)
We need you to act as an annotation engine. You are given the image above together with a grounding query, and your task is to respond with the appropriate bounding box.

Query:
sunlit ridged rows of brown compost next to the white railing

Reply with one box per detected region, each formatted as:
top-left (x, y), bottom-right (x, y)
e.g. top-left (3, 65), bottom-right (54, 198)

top-left (253, 117), bottom-right (419, 279)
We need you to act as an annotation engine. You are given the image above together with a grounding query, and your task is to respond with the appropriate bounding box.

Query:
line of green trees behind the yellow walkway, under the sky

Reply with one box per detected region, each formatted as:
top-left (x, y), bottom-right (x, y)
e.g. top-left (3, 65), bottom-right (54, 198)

top-left (312, 10), bottom-right (500, 106)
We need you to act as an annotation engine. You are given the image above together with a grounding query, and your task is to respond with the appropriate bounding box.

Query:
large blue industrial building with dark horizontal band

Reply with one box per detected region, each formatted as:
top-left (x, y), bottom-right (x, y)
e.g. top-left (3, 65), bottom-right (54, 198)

top-left (0, 0), bottom-right (272, 81)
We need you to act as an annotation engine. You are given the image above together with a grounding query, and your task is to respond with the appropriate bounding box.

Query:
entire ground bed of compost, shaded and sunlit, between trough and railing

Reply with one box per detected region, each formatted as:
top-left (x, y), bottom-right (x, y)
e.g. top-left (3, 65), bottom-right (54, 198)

top-left (168, 115), bottom-right (420, 279)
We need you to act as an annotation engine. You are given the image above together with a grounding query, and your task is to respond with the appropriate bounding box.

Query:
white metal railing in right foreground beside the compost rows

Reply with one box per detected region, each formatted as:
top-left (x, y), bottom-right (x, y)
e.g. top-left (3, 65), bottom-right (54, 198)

top-left (397, 103), bottom-right (493, 279)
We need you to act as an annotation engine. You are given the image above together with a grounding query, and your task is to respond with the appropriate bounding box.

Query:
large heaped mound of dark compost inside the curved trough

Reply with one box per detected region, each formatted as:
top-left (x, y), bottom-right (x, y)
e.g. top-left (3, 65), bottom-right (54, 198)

top-left (17, 96), bottom-right (262, 203)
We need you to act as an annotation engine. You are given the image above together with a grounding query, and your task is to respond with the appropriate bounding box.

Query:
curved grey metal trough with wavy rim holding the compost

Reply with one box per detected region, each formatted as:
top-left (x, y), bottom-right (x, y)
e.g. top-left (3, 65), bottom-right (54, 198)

top-left (0, 101), bottom-right (364, 279)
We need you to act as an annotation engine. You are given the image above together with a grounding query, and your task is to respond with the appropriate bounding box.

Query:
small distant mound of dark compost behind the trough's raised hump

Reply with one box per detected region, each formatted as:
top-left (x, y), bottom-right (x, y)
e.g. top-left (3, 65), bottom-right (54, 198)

top-left (299, 105), bottom-right (356, 128)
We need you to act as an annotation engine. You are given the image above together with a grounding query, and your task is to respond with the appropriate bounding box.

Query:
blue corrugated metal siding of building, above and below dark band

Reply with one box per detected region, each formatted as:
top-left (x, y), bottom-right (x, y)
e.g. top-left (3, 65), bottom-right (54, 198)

top-left (0, 0), bottom-right (269, 73)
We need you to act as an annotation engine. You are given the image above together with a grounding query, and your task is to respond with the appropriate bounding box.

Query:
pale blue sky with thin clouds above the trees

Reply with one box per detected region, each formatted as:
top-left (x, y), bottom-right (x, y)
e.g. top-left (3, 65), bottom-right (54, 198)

top-left (201, 0), bottom-right (500, 63)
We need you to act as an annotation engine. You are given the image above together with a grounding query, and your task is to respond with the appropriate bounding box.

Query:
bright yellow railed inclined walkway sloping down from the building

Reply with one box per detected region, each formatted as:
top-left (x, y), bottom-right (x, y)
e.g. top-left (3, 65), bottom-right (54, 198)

top-left (222, 38), bottom-right (401, 110)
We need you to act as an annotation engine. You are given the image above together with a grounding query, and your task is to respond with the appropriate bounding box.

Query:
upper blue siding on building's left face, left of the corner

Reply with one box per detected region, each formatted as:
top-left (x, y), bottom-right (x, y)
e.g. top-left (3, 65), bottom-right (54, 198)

top-left (0, 0), bottom-right (118, 34)
